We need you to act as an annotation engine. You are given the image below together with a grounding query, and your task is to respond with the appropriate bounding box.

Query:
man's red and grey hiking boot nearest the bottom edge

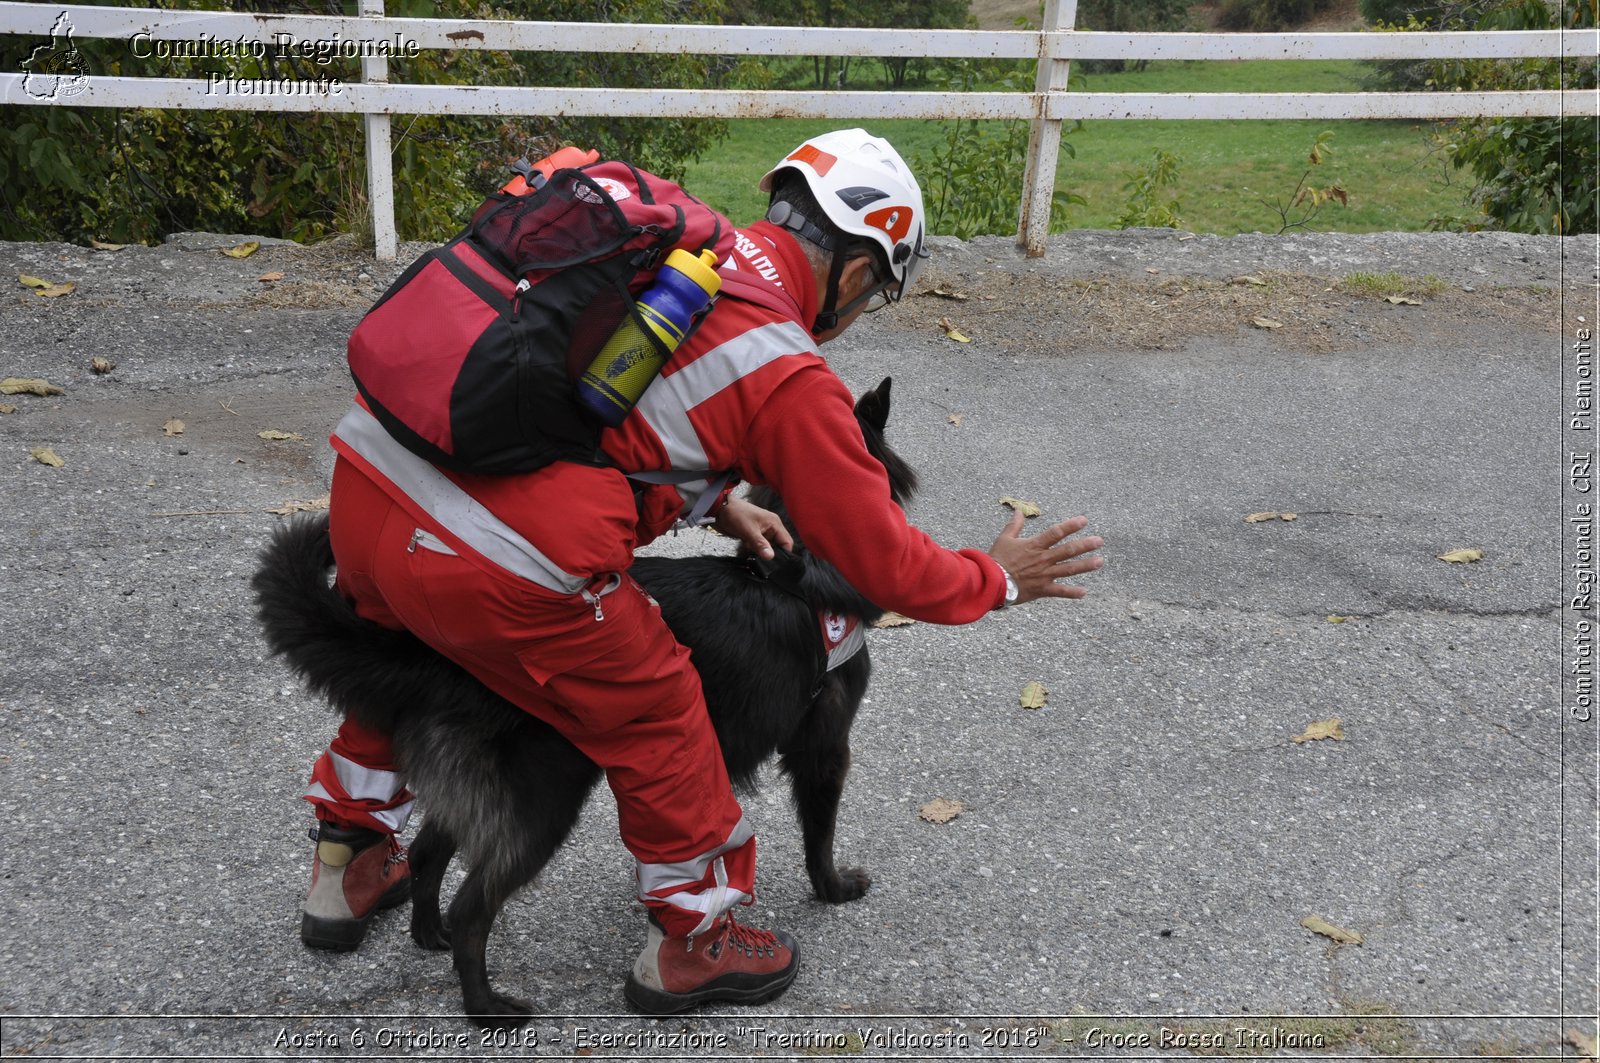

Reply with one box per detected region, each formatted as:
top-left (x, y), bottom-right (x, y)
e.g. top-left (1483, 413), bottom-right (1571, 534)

top-left (622, 913), bottom-right (800, 1015)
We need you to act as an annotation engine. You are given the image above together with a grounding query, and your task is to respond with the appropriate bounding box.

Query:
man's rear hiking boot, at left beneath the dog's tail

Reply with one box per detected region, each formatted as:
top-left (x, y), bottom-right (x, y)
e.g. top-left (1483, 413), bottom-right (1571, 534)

top-left (301, 821), bottom-right (411, 953)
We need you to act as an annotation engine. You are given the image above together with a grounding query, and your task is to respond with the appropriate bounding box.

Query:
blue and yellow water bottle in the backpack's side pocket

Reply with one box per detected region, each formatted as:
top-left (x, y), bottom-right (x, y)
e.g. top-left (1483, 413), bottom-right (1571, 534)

top-left (578, 248), bottom-right (722, 427)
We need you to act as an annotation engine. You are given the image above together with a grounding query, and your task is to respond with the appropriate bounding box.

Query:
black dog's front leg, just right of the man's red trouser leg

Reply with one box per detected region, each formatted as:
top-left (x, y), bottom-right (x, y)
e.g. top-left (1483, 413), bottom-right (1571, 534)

top-left (782, 669), bottom-right (872, 905)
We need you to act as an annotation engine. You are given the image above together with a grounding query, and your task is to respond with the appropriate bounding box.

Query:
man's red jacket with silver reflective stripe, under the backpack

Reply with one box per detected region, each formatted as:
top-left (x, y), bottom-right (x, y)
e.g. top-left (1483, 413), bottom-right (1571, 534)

top-left (333, 221), bottom-right (1005, 624)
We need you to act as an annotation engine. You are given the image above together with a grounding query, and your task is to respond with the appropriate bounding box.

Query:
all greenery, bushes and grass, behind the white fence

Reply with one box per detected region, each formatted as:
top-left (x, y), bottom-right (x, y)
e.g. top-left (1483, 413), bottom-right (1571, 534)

top-left (0, 0), bottom-right (1600, 242)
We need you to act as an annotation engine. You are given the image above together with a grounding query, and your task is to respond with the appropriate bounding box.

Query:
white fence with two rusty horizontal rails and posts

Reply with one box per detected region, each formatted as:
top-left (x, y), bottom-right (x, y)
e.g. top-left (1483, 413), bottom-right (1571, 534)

top-left (0, 0), bottom-right (1600, 259)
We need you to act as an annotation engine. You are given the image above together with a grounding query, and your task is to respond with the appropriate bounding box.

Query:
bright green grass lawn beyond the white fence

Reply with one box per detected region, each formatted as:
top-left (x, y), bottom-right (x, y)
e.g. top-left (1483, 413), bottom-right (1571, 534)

top-left (686, 61), bottom-right (1470, 235)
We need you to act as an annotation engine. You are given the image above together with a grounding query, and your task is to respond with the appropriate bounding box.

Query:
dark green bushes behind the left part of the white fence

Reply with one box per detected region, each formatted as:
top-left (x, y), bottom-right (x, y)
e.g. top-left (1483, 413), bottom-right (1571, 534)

top-left (0, 0), bottom-right (742, 243)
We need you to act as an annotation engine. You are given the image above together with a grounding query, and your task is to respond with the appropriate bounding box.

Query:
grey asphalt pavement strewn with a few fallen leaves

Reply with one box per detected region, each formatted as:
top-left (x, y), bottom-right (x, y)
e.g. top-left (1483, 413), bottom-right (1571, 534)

top-left (0, 234), bottom-right (1597, 1058)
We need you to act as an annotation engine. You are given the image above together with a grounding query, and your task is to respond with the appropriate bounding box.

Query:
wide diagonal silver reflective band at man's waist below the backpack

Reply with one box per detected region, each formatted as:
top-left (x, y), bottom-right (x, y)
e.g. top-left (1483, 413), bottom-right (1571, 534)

top-left (333, 407), bottom-right (589, 594)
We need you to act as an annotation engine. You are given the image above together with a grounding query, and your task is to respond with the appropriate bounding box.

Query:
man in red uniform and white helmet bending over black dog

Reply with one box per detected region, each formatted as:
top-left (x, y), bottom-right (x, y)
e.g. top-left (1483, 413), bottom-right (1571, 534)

top-left (302, 130), bottom-right (1101, 1013)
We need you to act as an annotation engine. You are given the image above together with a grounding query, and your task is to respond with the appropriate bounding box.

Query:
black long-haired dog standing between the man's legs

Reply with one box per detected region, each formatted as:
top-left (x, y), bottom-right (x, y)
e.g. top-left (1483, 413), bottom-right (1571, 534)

top-left (253, 379), bottom-right (915, 1026)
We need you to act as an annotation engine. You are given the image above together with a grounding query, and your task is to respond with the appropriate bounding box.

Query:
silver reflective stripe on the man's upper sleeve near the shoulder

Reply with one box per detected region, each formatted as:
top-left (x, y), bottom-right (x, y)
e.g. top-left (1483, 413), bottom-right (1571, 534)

top-left (635, 322), bottom-right (816, 469)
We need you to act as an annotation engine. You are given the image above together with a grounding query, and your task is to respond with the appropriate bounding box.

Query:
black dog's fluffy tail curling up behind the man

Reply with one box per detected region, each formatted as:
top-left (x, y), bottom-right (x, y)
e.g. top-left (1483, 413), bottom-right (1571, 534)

top-left (250, 514), bottom-right (454, 733)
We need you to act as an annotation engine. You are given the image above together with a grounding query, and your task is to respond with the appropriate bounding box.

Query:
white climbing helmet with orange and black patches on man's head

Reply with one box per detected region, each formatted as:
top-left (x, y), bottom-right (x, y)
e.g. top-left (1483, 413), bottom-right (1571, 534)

top-left (760, 130), bottom-right (928, 301)
